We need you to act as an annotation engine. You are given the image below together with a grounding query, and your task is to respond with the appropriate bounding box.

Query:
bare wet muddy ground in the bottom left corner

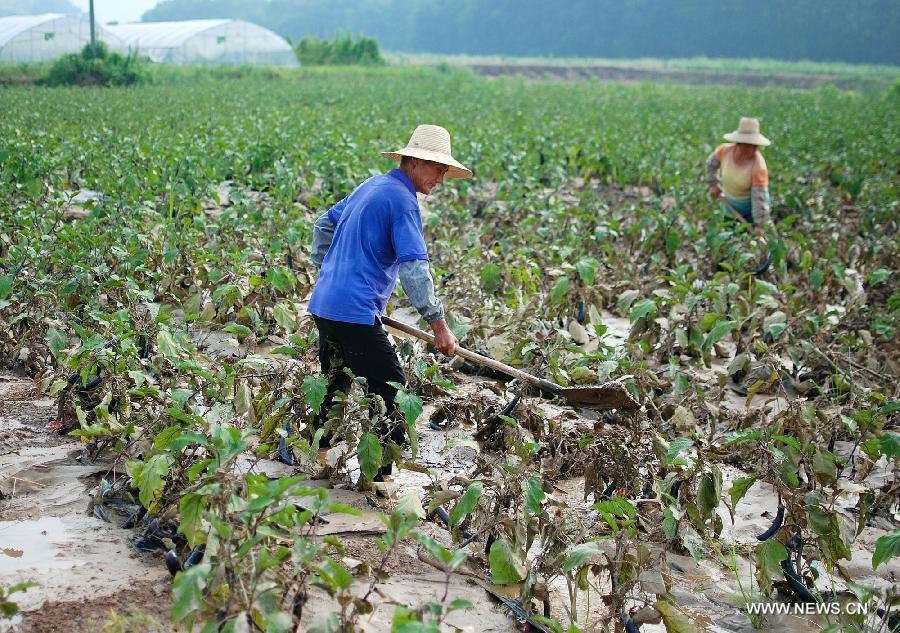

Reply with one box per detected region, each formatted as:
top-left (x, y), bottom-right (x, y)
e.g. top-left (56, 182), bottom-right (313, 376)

top-left (0, 374), bottom-right (171, 632)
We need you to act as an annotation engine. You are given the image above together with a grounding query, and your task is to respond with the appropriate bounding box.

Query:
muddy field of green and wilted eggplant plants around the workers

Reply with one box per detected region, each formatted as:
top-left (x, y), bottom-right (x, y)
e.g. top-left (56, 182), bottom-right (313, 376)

top-left (0, 67), bottom-right (900, 633)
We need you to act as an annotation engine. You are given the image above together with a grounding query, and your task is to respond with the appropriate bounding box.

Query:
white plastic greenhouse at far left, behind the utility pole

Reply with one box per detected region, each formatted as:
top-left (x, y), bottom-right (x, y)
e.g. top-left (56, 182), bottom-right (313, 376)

top-left (0, 13), bottom-right (121, 63)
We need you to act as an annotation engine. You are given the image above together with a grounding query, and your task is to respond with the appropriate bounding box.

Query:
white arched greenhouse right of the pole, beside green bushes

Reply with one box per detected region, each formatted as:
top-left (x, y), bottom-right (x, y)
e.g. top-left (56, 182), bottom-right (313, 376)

top-left (109, 20), bottom-right (298, 66)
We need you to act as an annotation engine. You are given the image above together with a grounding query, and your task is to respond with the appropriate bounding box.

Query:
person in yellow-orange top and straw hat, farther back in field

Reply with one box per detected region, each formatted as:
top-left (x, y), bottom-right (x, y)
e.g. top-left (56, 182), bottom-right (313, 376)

top-left (706, 117), bottom-right (770, 235)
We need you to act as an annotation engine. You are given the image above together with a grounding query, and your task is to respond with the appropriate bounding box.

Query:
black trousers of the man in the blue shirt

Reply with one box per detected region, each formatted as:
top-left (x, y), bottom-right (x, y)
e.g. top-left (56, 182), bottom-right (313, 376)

top-left (313, 315), bottom-right (406, 464)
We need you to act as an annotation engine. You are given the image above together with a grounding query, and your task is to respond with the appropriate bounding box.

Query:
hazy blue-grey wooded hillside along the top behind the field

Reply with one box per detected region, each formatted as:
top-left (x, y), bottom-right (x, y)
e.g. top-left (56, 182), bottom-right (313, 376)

top-left (8, 0), bottom-right (900, 65)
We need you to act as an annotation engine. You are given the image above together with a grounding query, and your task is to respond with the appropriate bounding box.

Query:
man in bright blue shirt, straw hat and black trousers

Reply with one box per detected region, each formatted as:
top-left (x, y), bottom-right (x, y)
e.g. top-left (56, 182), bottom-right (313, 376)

top-left (309, 125), bottom-right (472, 481)
